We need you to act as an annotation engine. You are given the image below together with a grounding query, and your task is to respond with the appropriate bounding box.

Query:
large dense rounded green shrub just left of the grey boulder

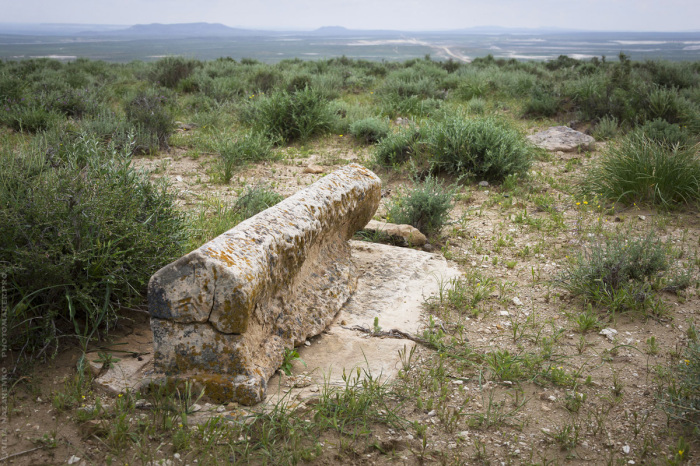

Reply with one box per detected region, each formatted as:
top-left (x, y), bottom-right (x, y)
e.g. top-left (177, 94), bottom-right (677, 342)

top-left (425, 115), bottom-right (533, 180)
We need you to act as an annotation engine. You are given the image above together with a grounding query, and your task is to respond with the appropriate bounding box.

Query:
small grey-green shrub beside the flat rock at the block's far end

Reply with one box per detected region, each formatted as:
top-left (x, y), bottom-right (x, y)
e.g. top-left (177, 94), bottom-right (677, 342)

top-left (387, 176), bottom-right (457, 235)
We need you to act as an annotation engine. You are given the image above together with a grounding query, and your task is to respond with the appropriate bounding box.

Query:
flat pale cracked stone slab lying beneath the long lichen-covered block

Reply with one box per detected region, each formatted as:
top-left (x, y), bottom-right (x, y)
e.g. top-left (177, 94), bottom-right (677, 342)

top-left (93, 241), bottom-right (461, 408)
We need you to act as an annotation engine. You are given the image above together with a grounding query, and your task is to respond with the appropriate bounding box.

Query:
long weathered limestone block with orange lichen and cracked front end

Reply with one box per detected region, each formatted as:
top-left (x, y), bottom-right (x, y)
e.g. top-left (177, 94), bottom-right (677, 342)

top-left (148, 164), bottom-right (381, 405)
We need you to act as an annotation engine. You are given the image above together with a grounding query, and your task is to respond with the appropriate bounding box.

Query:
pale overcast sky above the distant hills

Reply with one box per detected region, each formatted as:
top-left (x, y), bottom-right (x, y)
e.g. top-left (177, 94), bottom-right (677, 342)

top-left (0, 0), bottom-right (700, 31)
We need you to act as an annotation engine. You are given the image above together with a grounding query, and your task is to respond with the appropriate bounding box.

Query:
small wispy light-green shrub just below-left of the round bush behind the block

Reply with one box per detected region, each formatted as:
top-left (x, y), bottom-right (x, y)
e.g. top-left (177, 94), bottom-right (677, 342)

top-left (214, 131), bottom-right (273, 183)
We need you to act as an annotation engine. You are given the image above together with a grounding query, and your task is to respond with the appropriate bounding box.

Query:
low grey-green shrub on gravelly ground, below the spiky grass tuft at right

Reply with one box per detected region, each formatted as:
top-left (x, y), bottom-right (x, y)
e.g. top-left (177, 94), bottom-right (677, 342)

top-left (558, 232), bottom-right (686, 312)
